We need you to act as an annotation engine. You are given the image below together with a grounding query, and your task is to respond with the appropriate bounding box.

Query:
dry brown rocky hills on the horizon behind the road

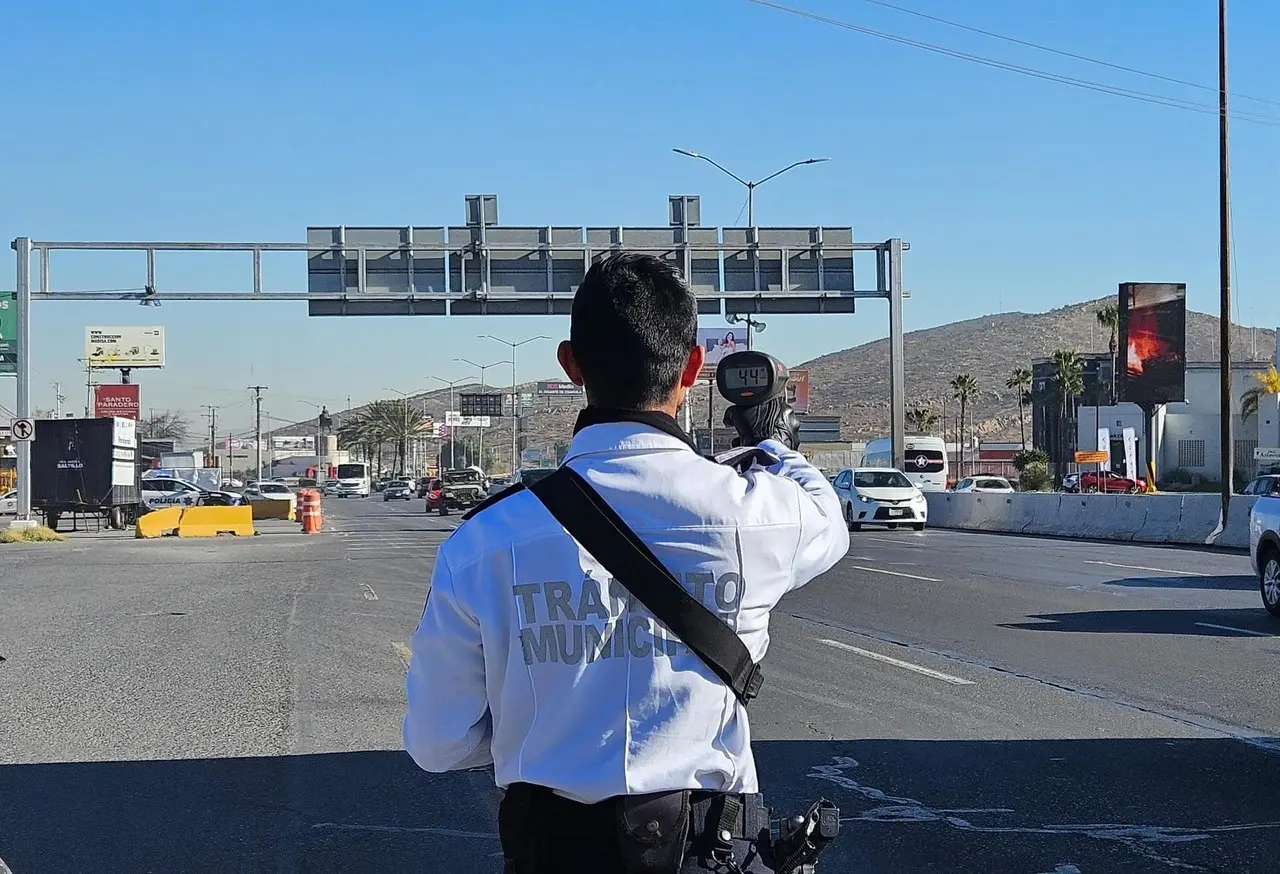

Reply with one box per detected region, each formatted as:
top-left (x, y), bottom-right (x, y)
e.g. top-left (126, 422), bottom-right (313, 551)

top-left (273, 297), bottom-right (1275, 458)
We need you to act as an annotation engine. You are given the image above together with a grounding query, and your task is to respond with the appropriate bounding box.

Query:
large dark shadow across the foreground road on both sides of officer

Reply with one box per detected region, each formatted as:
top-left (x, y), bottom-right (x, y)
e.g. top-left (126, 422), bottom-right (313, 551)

top-left (0, 727), bottom-right (1280, 874)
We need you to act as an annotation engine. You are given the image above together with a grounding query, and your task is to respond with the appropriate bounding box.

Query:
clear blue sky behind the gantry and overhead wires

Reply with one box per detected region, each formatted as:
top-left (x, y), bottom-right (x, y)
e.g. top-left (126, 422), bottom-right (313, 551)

top-left (0, 0), bottom-right (1280, 431)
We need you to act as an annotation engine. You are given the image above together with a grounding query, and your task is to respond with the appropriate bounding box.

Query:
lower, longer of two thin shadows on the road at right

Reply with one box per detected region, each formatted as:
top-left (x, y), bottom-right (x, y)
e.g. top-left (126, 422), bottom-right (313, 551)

top-left (1000, 607), bottom-right (1280, 637)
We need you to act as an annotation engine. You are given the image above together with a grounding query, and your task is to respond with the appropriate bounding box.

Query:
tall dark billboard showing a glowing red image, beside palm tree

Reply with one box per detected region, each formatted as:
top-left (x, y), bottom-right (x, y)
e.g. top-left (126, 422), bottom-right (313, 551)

top-left (1117, 283), bottom-right (1187, 407)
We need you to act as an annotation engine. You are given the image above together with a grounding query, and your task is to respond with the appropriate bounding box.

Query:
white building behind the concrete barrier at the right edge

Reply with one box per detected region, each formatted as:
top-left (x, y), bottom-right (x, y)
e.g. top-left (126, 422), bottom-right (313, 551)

top-left (1076, 361), bottom-right (1280, 481)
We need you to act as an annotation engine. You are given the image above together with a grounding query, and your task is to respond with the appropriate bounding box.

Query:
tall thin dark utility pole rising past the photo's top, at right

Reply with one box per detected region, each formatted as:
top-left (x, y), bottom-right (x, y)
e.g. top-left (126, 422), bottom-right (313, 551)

top-left (1217, 0), bottom-right (1235, 519)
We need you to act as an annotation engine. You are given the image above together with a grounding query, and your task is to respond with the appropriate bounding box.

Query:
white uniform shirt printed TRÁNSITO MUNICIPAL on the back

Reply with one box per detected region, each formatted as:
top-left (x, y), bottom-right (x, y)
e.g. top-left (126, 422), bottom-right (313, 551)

top-left (404, 422), bottom-right (849, 804)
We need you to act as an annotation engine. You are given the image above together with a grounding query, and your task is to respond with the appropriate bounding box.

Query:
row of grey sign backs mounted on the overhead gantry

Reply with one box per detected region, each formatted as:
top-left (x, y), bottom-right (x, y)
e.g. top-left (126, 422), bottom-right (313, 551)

top-left (300, 224), bottom-right (860, 316)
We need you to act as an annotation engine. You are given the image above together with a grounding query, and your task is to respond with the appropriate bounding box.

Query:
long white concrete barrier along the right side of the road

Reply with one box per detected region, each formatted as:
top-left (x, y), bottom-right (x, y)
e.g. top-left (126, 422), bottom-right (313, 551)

top-left (925, 491), bottom-right (1257, 549)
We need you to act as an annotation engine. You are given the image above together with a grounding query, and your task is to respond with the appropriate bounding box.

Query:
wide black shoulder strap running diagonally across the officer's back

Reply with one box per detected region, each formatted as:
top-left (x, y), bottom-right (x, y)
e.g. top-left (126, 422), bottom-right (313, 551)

top-left (529, 465), bottom-right (764, 705)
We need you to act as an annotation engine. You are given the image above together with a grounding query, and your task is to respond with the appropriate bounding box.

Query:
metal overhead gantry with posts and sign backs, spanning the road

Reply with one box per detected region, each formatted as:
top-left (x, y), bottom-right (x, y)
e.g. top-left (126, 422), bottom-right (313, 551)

top-left (13, 224), bottom-right (908, 525)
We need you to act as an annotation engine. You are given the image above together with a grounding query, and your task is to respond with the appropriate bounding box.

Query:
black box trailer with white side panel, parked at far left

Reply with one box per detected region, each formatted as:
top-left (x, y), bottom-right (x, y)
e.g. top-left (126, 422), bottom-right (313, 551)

top-left (31, 418), bottom-right (141, 531)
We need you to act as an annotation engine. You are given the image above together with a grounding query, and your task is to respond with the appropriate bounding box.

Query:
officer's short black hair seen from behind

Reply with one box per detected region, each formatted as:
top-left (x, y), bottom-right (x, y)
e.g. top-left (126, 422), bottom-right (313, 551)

top-left (570, 252), bottom-right (698, 409)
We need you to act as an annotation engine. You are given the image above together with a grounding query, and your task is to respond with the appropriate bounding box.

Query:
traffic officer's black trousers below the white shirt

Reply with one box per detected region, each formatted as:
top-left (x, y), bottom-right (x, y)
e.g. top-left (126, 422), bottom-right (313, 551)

top-left (498, 783), bottom-right (773, 874)
